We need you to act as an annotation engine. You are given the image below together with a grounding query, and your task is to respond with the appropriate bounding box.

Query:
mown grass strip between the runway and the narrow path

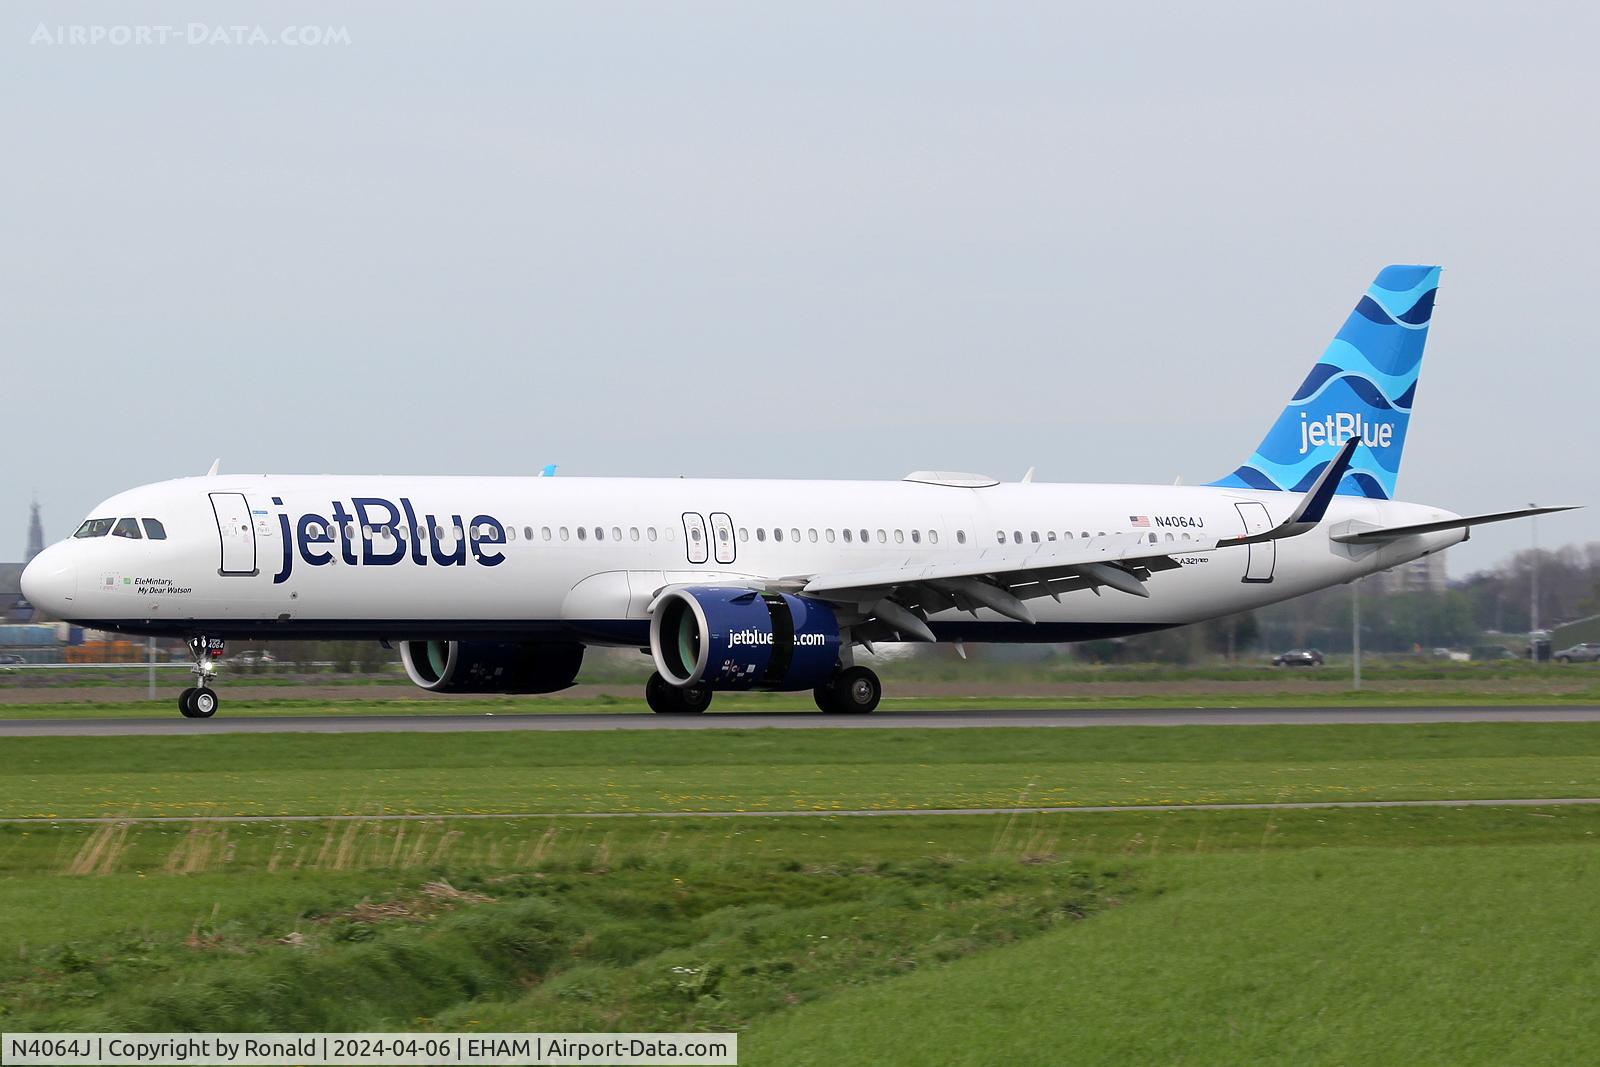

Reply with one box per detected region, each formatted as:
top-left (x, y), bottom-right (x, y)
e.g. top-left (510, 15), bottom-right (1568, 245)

top-left (0, 723), bottom-right (1600, 817)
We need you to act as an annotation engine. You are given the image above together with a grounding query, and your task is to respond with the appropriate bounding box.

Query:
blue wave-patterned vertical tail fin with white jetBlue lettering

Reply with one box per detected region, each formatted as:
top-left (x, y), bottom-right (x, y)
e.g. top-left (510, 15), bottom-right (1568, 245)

top-left (1211, 267), bottom-right (1438, 501)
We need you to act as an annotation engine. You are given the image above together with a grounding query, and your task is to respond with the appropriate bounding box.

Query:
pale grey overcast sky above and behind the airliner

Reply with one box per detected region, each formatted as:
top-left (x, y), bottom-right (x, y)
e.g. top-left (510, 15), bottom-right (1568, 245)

top-left (0, 2), bottom-right (1600, 574)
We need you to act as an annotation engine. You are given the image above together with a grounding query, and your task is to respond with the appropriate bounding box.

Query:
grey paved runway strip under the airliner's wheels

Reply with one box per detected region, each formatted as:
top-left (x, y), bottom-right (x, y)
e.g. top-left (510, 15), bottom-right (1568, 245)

top-left (0, 704), bottom-right (1600, 737)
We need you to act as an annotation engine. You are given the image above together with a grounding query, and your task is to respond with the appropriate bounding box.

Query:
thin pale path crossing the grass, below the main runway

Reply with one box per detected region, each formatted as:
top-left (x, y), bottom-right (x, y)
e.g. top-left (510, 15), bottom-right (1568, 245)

top-left (0, 797), bottom-right (1600, 825)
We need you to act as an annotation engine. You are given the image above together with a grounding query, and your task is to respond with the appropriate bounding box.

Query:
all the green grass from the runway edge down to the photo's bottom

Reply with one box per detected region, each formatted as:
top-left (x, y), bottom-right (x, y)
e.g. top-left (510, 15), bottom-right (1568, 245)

top-left (0, 723), bottom-right (1600, 1064)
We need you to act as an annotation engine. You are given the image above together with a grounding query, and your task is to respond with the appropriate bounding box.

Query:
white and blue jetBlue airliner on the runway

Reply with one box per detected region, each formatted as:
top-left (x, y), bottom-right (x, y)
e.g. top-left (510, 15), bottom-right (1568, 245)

top-left (22, 266), bottom-right (1563, 718)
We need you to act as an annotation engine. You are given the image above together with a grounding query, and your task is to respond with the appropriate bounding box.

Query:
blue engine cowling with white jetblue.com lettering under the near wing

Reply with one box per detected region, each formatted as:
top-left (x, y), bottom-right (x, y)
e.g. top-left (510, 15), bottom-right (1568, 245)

top-left (650, 585), bottom-right (838, 689)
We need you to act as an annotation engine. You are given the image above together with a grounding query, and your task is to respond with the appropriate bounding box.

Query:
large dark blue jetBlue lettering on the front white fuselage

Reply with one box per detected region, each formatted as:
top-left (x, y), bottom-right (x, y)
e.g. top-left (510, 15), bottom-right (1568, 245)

top-left (272, 496), bottom-right (506, 585)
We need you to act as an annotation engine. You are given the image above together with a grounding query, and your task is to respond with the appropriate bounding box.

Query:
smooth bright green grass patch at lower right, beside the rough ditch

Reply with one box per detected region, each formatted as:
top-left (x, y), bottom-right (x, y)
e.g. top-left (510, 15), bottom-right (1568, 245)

top-left (739, 838), bottom-right (1600, 1067)
